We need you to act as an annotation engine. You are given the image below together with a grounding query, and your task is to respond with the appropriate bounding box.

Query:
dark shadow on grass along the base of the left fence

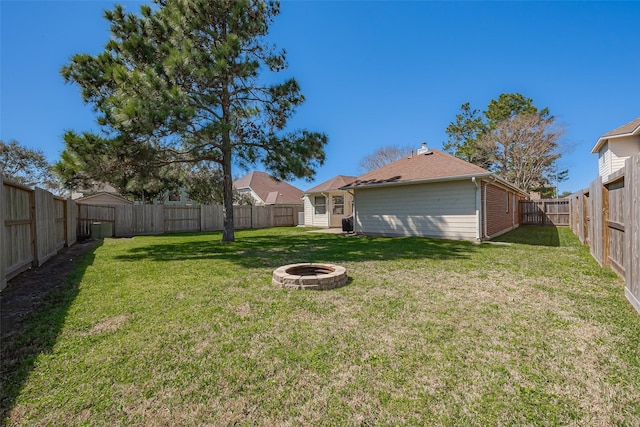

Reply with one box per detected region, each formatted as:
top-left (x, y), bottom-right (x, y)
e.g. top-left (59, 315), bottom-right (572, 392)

top-left (0, 241), bottom-right (102, 425)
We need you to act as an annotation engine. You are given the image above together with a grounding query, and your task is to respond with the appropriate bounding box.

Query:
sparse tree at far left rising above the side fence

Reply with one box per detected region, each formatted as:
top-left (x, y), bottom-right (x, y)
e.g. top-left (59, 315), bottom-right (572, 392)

top-left (0, 140), bottom-right (60, 193)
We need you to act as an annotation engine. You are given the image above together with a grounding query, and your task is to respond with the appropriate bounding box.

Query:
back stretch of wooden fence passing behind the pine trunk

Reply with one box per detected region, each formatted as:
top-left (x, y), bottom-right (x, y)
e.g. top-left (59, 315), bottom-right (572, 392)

top-left (78, 204), bottom-right (303, 237)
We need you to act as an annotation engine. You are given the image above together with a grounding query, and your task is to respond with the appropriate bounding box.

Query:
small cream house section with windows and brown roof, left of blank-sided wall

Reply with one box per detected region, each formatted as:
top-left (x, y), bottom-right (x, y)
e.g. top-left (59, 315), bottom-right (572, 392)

top-left (302, 175), bottom-right (356, 227)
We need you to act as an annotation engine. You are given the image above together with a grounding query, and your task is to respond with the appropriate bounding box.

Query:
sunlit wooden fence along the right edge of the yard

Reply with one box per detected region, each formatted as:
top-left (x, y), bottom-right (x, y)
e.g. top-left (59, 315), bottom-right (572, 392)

top-left (569, 153), bottom-right (640, 312)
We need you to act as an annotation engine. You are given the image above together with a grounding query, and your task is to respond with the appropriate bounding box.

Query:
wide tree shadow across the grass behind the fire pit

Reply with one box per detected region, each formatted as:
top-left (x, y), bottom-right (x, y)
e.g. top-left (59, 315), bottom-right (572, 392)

top-left (116, 229), bottom-right (477, 268)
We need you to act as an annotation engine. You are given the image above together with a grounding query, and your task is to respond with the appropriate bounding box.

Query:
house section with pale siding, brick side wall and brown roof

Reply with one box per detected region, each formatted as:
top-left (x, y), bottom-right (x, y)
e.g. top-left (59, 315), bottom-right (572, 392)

top-left (341, 144), bottom-right (528, 240)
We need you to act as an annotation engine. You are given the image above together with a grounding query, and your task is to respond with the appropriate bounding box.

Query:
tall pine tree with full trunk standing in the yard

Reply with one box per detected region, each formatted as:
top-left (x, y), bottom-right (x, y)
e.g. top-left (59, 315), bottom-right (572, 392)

top-left (62, 0), bottom-right (327, 241)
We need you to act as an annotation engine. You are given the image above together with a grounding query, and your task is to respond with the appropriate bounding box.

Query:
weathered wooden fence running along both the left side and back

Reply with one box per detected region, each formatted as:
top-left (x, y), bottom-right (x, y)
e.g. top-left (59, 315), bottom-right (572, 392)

top-left (0, 175), bottom-right (303, 290)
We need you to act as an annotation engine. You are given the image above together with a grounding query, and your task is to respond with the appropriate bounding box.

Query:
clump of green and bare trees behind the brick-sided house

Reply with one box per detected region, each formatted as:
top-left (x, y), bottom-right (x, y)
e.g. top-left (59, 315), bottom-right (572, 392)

top-left (444, 93), bottom-right (568, 195)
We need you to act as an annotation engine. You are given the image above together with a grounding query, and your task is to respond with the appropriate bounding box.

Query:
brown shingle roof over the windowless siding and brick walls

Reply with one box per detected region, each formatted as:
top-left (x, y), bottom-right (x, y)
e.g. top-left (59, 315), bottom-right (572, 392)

top-left (342, 147), bottom-right (528, 196)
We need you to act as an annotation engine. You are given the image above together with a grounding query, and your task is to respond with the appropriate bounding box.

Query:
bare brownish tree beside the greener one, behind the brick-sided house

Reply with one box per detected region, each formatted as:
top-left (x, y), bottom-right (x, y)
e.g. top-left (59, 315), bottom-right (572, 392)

top-left (478, 113), bottom-right (567, 191)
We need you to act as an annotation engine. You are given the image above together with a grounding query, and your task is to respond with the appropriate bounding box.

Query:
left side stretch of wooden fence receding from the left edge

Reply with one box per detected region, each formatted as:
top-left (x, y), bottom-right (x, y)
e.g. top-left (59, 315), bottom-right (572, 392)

top-left (0, 175), bottom-right (78, 289)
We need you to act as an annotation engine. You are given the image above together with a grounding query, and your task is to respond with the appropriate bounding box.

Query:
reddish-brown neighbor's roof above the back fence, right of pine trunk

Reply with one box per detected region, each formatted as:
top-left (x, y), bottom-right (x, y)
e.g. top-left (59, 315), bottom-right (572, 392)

top-left (233, 171), bottom-right (303, 205)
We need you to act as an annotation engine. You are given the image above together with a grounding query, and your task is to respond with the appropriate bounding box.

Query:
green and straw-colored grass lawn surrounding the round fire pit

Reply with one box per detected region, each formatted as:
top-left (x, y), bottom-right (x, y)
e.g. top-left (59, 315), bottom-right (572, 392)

top-left (2, 227), bottom-right (640, 426)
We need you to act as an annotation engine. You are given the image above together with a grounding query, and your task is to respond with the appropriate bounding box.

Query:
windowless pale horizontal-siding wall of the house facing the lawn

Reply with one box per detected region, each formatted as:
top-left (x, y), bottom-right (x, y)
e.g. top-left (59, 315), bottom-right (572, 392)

top-left (355, 179), bottom-right (478, 240)
